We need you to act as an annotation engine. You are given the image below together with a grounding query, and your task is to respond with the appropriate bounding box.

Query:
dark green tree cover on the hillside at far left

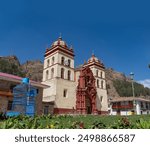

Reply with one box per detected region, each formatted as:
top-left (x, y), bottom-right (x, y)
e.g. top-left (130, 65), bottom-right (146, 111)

top-left (0, 59), bottom-right (25, 77)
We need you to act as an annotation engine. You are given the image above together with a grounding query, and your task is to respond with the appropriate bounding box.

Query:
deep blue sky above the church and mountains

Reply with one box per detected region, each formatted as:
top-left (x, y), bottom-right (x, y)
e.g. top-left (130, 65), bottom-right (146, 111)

top-left (0, 0), bottom-right (150, 85)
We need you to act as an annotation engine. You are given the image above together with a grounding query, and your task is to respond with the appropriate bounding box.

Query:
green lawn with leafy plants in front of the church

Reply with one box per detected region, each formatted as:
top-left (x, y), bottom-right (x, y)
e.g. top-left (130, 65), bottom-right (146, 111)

top-left (0, 115), bottom-right (150, 129)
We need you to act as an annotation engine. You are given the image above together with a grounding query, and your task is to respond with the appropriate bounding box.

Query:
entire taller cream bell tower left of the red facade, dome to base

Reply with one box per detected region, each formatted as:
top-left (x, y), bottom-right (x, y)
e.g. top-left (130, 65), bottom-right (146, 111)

top-left (43, 37), bottom-right (75, 113)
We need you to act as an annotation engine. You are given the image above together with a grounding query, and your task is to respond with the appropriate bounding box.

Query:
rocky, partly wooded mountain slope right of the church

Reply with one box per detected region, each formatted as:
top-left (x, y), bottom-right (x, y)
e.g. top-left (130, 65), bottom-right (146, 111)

top-left (106, 68), bottom-right (150, 98)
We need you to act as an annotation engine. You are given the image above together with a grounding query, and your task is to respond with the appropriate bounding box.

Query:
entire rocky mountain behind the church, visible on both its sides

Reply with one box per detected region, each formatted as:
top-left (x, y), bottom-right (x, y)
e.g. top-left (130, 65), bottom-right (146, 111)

top-left (0, 56), bottom-right (150, 98)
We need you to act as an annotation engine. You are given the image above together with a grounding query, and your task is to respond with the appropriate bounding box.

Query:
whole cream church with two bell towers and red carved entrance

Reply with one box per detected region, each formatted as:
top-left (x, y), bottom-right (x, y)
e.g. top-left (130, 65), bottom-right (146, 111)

top-left (42, 37), bottom-right (108, 115)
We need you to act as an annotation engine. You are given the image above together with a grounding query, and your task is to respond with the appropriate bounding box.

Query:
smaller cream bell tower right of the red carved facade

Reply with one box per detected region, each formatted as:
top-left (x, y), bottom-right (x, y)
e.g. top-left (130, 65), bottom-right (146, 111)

top-left (84, 54), bottom-right (108, 114)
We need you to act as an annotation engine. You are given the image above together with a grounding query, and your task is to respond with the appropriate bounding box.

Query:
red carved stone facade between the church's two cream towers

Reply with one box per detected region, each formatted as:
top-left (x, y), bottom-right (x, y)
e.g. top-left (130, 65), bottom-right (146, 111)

top-left (76, 66), bottom-right (98, 114)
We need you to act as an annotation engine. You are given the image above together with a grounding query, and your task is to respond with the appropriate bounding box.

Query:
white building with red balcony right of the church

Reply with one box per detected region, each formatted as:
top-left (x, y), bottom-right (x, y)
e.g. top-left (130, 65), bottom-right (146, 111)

top-left (110, 97), bottom-right (150, 115)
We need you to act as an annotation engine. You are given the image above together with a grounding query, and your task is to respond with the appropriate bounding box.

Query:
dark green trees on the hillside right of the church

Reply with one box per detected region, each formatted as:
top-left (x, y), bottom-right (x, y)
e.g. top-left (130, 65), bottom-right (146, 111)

top-left (113, 80), bottom-right (150, 97)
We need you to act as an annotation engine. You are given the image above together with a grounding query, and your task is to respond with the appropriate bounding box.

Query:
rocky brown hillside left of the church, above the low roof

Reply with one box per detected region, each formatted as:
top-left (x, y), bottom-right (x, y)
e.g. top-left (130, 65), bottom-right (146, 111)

top-left (0, 56), bottom-right (43, 82)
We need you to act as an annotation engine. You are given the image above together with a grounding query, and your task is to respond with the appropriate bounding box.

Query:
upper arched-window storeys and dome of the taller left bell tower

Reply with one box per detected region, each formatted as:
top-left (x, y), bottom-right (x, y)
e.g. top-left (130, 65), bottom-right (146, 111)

top-left (43, 37), bottom-right (74, 81)
